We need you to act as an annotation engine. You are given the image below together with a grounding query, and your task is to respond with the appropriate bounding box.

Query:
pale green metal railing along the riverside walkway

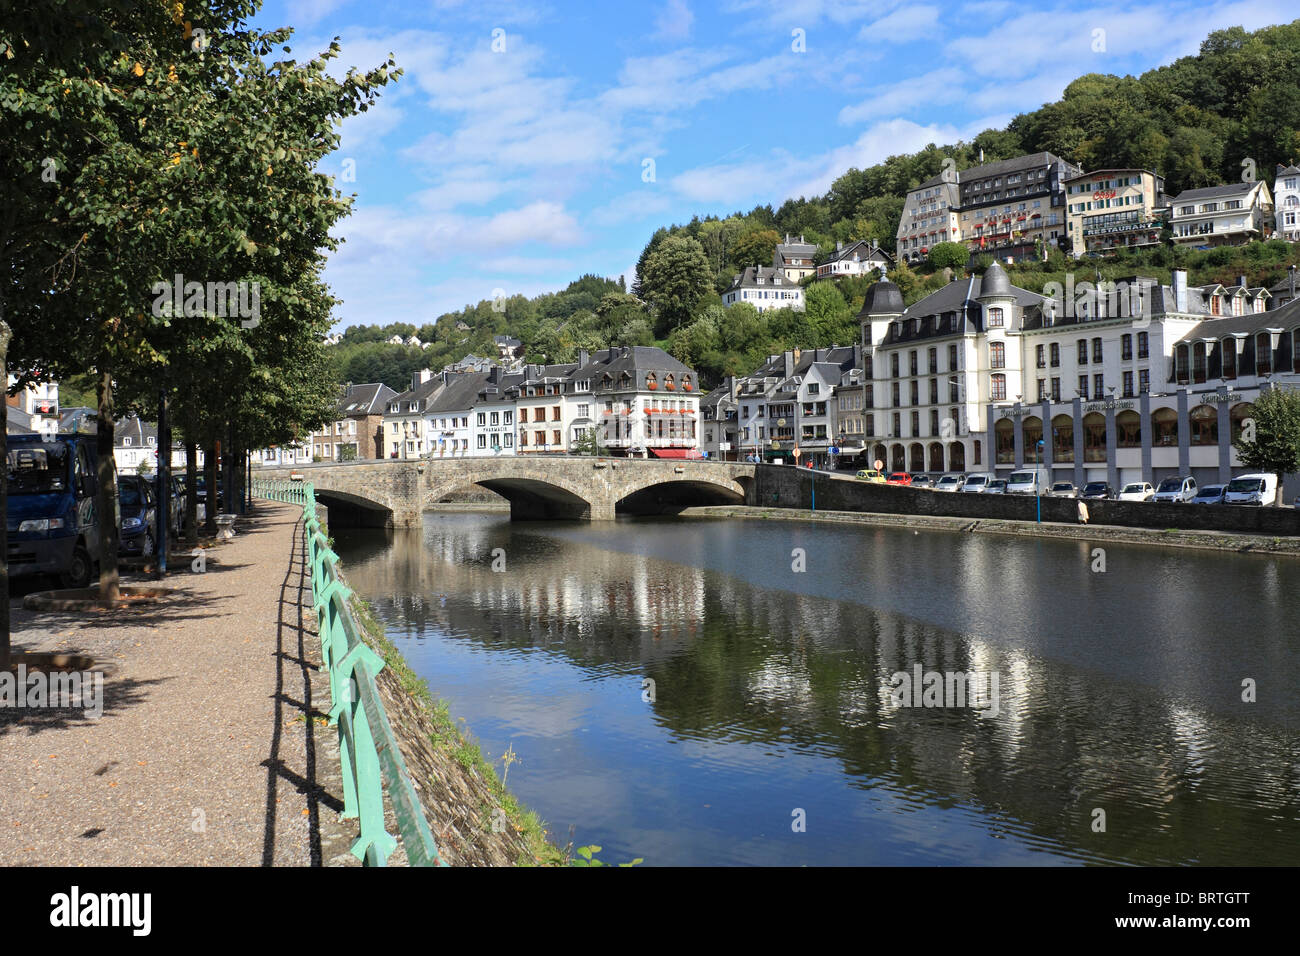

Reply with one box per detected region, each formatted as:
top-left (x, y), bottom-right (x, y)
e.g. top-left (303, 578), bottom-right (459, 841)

top-left (252, 479), bottom-right (446, 866)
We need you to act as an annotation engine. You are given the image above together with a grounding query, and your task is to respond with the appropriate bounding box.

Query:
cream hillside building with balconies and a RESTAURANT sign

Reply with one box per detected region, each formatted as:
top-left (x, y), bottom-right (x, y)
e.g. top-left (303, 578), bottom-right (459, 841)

top-left (1065, 169), bottom-right (1169, 256)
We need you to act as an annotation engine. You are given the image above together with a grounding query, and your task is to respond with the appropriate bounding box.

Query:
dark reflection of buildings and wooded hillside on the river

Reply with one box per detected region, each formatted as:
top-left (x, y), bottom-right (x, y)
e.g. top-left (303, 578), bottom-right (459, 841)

top-left (339, 514), bottom-right (1300, 864)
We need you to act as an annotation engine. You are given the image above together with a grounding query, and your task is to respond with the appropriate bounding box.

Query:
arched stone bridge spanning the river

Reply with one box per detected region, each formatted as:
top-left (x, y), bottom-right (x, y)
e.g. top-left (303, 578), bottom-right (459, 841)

top-left (254, 455), bottom-right (755, 527)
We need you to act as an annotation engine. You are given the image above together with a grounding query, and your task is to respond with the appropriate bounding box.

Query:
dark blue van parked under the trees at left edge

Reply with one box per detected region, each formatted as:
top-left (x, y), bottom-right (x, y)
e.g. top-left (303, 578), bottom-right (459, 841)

top-left (7, 434), bottom-right (100, 588)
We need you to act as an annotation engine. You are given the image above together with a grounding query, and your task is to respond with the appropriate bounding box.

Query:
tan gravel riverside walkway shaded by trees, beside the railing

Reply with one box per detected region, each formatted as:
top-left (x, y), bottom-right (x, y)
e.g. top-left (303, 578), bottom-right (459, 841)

top-left (0, 502), bottom-right (355, 866)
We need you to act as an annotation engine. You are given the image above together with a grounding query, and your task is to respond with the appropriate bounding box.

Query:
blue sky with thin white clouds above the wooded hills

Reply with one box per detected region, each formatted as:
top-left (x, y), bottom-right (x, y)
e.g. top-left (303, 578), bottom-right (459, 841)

top-left (255, 0), bottom-right (1295, 329)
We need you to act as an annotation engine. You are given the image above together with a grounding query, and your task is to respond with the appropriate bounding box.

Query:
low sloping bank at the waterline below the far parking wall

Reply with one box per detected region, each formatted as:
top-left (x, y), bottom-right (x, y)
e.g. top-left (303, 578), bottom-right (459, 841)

top-left (681, 505), bottom-right (1300, 557)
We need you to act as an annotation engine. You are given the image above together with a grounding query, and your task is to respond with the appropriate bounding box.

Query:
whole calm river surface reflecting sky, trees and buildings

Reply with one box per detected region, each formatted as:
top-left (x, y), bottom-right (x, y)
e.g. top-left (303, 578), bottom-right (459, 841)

top-left (338, 512), bottom-right (1300, 865)
